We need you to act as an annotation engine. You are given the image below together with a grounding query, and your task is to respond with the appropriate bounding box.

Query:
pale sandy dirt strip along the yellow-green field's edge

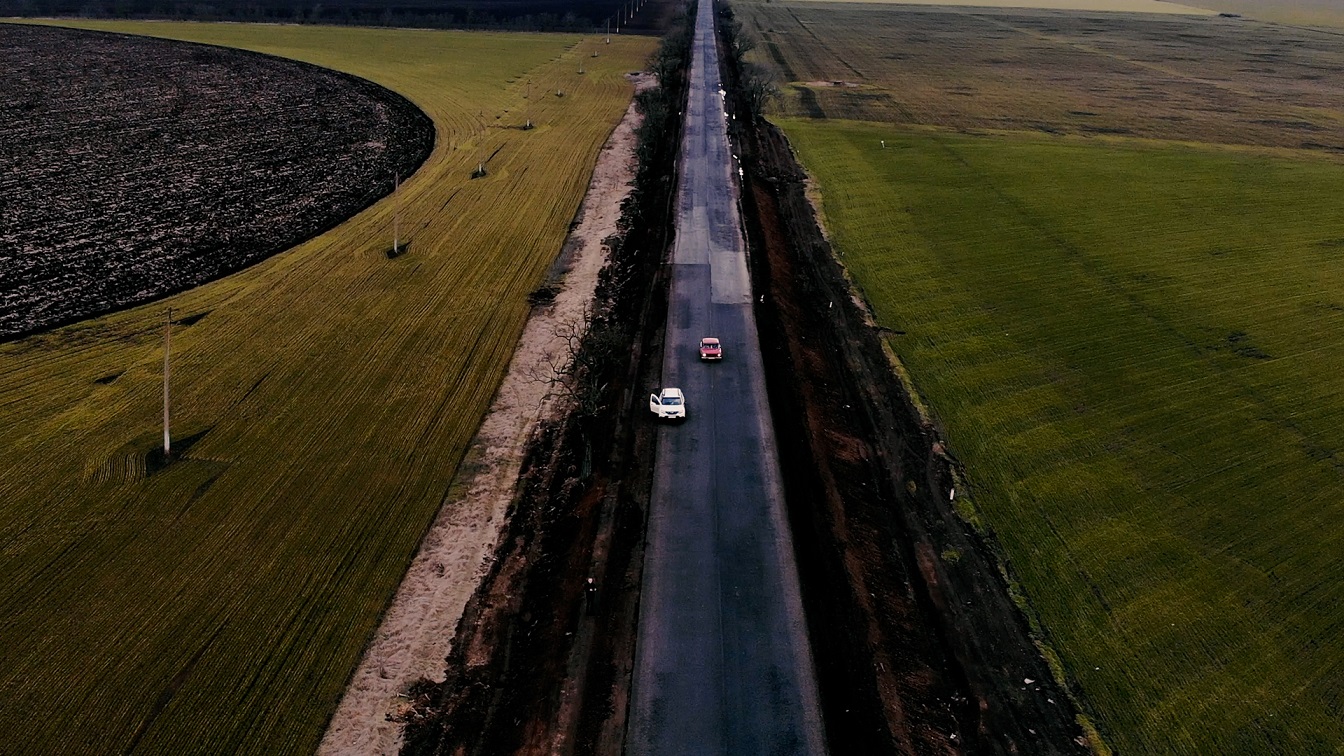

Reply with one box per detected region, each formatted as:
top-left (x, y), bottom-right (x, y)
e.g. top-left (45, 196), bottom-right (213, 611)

top-left (317, 75), bottom-right (655, 756)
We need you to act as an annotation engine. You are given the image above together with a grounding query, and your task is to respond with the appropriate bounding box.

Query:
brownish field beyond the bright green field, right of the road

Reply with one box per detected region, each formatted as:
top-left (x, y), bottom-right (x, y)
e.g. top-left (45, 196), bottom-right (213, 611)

top-left (734, 3), bottom-right (1344, 152)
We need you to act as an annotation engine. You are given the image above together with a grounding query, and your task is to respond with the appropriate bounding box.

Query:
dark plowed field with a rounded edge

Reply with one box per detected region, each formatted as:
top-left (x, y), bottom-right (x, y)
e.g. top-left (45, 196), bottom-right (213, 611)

top-left (0, 24), bottom-right (434, 340)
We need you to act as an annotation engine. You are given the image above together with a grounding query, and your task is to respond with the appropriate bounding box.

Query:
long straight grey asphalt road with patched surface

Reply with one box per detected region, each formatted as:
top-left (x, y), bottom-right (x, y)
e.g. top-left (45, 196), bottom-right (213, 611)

top-left (626, 0), bottom-right (824, 756)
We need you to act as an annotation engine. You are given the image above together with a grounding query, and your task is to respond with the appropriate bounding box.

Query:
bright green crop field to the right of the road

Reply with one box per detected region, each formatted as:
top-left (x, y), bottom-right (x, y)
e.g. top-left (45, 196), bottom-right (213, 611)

top-left (781, 118), bottom-right (1344, 755)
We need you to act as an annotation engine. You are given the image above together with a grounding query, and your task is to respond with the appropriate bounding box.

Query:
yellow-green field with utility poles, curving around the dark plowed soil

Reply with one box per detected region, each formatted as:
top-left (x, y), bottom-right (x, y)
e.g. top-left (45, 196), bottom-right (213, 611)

top-left (0, 23), bottom-right (653, 753)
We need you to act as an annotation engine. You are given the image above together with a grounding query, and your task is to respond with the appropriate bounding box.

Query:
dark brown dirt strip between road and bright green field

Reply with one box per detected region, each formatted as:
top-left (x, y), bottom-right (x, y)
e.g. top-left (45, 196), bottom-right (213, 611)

top-left (723, 8), bottom-right (1089, 753)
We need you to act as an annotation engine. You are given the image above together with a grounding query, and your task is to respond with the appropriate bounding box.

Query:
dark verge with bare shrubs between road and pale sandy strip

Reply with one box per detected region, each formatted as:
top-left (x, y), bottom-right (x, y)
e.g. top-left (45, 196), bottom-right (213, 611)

top-left (398, 17), bottom-right (689, 755)
